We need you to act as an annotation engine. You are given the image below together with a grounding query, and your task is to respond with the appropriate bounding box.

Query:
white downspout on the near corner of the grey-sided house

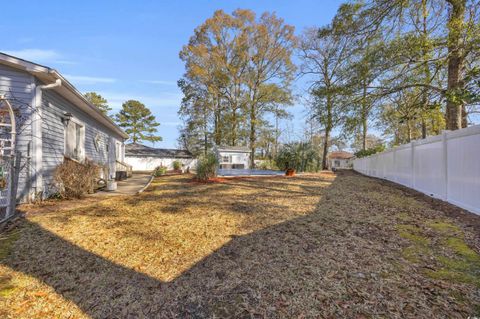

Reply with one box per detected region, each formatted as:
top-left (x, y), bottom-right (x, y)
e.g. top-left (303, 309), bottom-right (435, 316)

top-left (32, 79), bottom-right (62, 199)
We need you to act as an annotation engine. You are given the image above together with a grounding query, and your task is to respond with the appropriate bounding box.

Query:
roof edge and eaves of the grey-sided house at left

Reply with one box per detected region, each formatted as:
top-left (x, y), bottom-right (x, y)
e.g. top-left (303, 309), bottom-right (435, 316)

top-left (0, 52), bottom-right (128, 139)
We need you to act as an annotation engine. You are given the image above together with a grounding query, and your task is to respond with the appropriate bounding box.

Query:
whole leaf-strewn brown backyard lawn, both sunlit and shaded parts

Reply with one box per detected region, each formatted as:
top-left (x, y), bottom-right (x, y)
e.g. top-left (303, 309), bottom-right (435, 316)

top-left (0, 173), bottom-right (480, 318)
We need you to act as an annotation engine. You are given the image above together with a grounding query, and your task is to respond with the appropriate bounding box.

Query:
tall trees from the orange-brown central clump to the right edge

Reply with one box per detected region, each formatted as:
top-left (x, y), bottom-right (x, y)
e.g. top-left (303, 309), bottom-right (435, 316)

top-left (178, 0), bottom-right (480, 168)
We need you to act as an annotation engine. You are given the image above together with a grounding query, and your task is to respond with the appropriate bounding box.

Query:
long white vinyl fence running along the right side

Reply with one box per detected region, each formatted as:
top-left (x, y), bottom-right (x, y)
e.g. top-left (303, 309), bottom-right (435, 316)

top-left (353, 125), bottom-right (480, 214)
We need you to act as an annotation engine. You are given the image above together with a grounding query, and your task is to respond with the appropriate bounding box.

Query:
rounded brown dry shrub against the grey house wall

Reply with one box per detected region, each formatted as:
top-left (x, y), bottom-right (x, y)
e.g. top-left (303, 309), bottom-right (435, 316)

top-left (54, 158), bottom-right (100, 198)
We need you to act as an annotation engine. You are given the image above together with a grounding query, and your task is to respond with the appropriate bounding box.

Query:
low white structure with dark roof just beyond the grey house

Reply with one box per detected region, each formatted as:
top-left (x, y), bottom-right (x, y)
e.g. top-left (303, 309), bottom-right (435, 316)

top-left (125, 143), bottom-right (197, 171)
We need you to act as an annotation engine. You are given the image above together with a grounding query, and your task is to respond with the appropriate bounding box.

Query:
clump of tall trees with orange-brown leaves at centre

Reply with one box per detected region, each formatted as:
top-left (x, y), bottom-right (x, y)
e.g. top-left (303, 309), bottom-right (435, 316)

top-left (178, 9), bottom-right (296, 165)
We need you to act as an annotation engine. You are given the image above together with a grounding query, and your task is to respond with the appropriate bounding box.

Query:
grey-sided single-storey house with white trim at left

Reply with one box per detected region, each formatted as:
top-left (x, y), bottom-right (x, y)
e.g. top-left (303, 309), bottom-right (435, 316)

top-left (0, 53), bottom-right (128, 201)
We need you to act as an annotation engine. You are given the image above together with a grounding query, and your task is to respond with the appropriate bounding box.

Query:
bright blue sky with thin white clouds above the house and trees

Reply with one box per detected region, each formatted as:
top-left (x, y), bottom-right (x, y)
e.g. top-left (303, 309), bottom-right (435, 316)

top-left (0, 0), bottom-right (342, 147)
